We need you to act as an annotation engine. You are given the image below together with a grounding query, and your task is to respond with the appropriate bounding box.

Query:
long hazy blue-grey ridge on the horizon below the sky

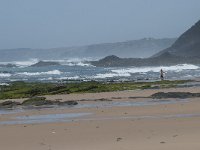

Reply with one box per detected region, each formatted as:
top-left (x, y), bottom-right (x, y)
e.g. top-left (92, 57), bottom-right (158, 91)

top-left (0, 38), bottom-right (176, 61)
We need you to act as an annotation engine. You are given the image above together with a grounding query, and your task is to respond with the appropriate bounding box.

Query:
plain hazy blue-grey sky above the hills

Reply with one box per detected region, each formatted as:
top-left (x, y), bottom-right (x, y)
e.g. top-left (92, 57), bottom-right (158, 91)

top-left (0, 0), bottom-right (200, 49)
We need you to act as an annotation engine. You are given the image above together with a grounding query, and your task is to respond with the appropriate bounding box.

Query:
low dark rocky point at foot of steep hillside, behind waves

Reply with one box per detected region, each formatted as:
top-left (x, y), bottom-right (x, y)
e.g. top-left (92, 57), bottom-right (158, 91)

top-left (90, 52), bottom-right (200, 67)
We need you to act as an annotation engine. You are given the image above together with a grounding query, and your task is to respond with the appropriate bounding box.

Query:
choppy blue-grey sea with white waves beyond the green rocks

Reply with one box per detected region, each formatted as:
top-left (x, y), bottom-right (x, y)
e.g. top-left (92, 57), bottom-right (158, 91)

top-left (0, 59), bottom-right (200, 85)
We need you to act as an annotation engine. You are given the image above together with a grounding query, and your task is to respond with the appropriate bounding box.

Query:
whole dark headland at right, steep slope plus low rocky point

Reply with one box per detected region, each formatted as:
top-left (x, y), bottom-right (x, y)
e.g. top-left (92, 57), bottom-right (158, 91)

top-left (91, 21), bottom-right (200, 67)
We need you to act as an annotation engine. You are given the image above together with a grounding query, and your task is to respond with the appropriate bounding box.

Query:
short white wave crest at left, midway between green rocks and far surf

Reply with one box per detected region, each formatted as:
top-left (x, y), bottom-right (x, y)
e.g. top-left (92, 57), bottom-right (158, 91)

top-left (17, 70), bottom-right (62, 76)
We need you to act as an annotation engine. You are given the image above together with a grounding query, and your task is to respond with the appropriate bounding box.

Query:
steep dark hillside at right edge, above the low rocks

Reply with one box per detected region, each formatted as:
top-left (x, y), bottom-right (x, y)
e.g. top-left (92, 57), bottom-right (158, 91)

top-left (153, 21), bottom-right (200, 57)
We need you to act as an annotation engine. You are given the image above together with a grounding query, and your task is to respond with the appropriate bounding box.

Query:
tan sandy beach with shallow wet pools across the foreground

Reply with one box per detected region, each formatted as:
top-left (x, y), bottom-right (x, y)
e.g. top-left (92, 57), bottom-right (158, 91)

top-left (0, 87), bottom-right (200, 150)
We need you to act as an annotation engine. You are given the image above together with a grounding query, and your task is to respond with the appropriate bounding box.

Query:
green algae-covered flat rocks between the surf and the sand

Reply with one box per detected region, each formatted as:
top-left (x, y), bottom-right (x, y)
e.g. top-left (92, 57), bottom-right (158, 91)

top-left (0, 80), bottom-right (189, 99)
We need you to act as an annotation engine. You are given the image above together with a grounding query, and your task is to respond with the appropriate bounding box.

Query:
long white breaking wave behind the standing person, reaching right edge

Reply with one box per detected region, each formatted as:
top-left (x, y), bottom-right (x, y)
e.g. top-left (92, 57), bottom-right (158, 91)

top-left (112, 64), bottom-right (199, 74)
